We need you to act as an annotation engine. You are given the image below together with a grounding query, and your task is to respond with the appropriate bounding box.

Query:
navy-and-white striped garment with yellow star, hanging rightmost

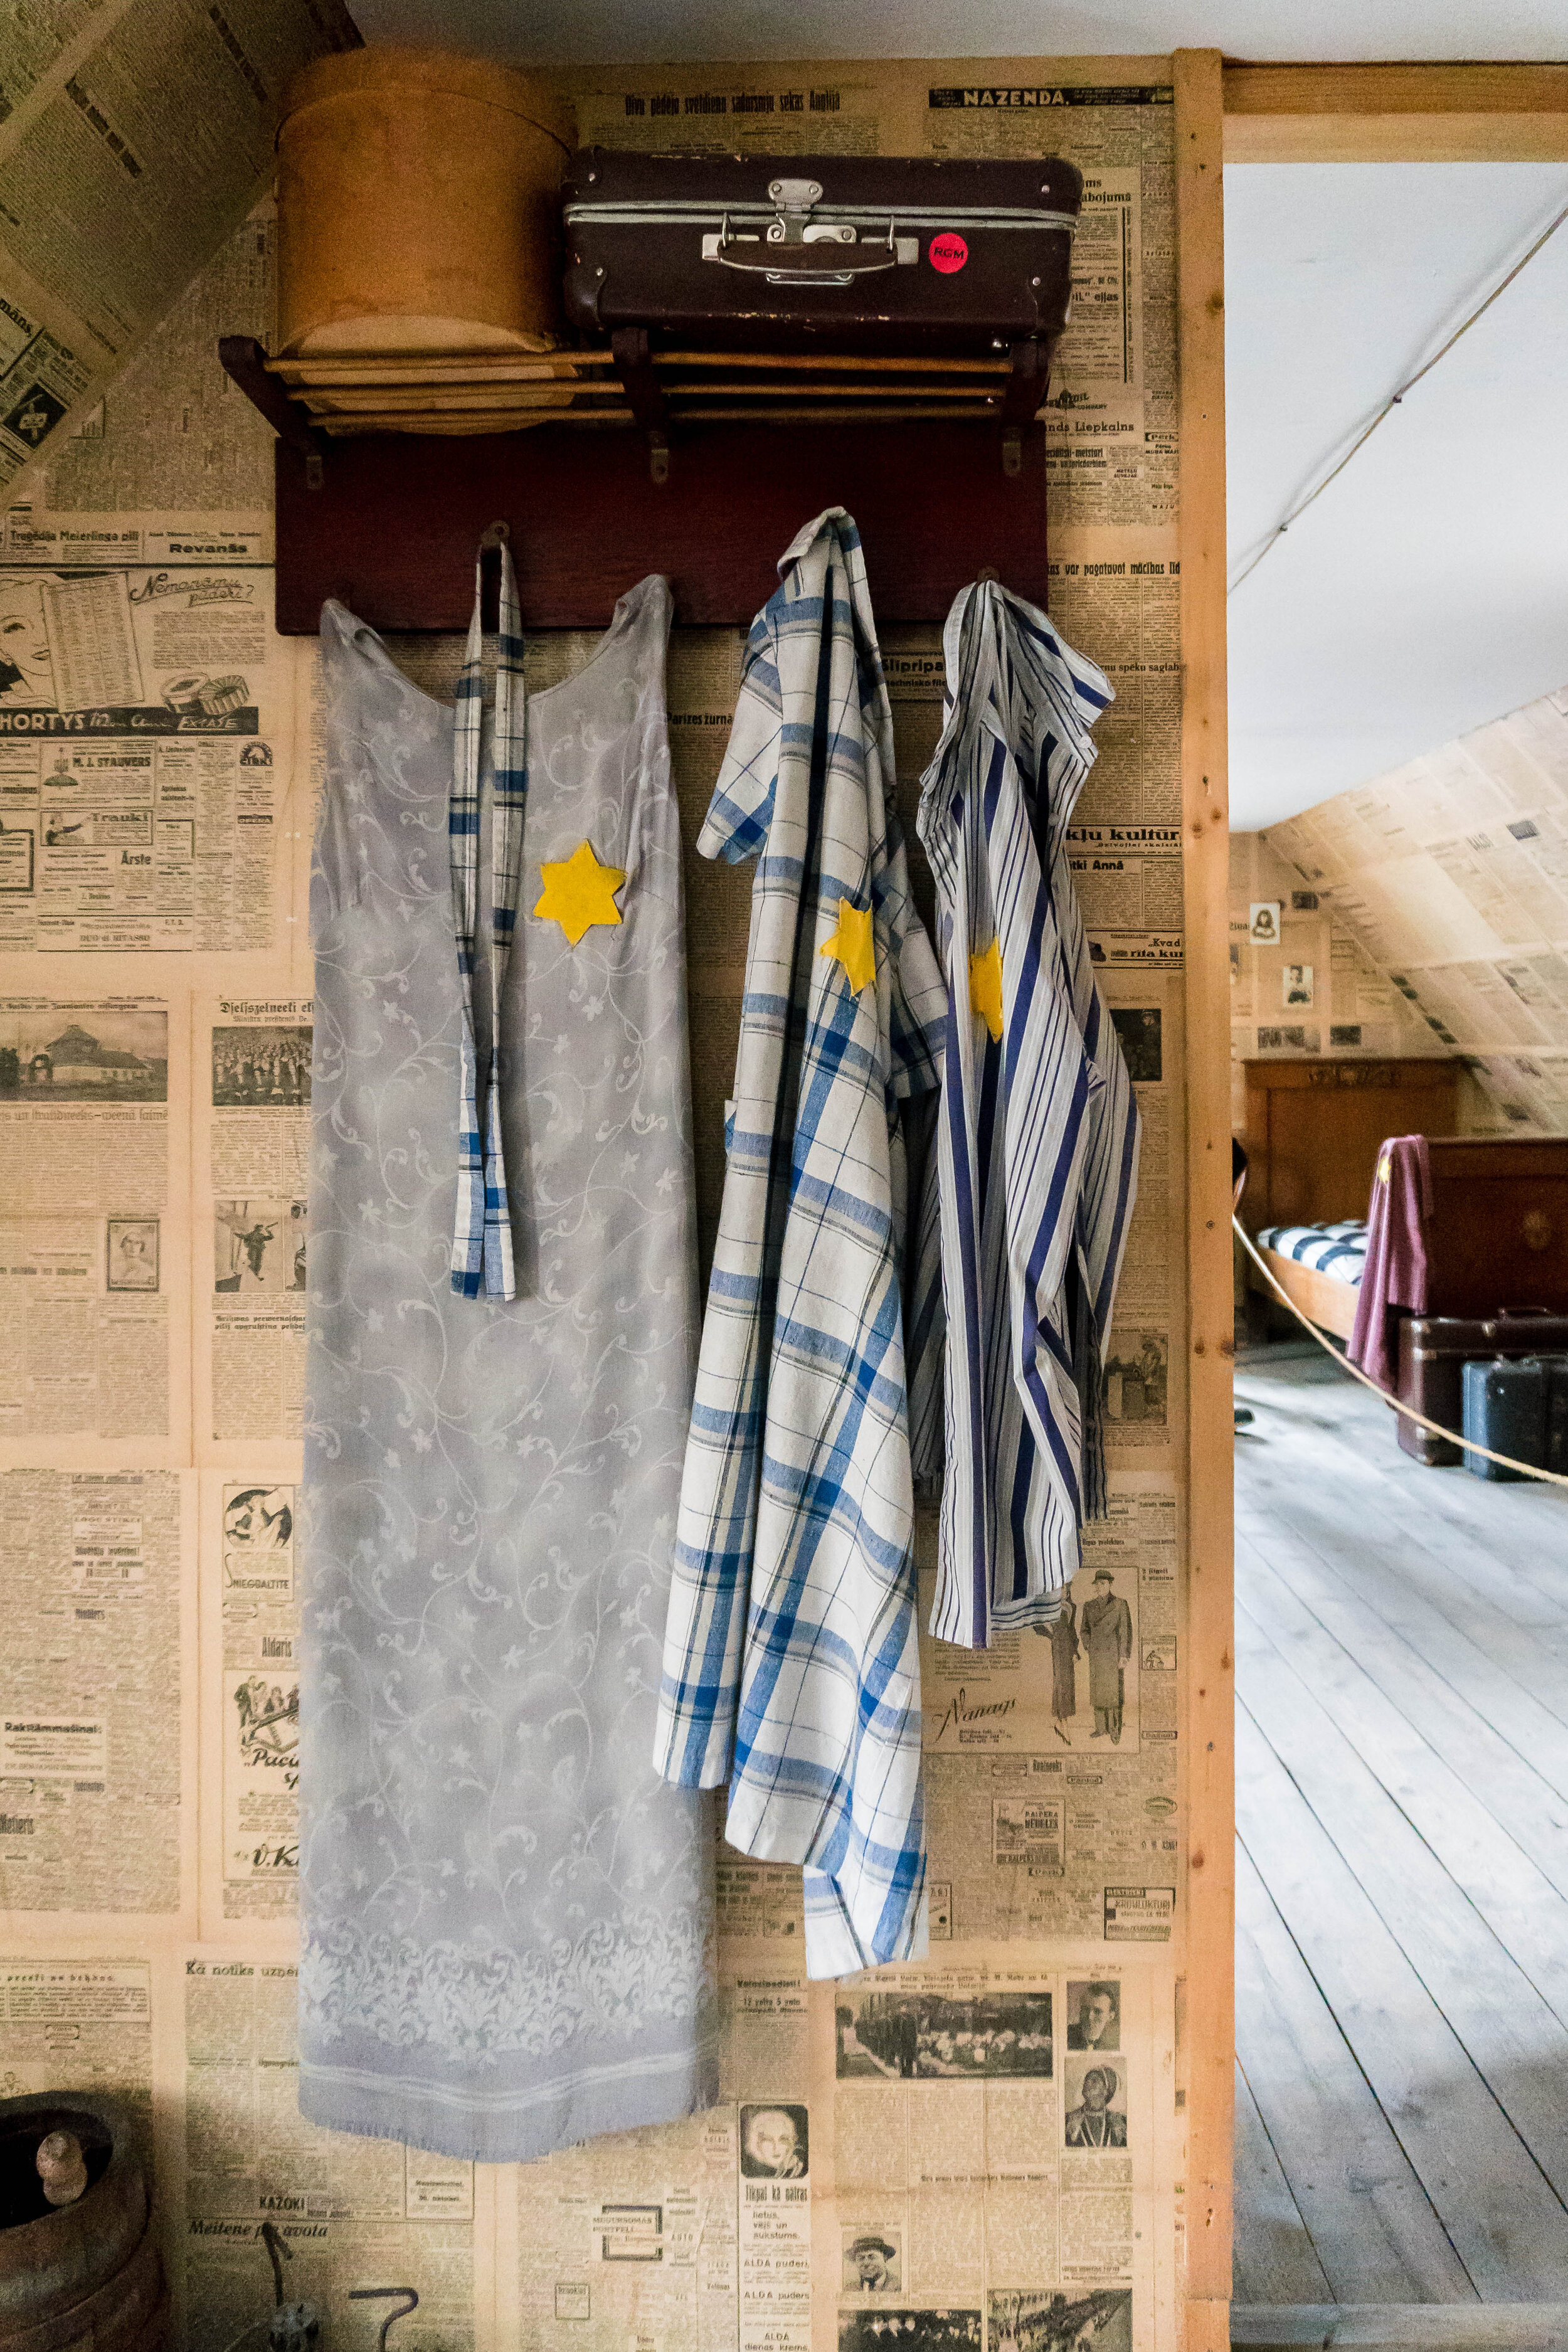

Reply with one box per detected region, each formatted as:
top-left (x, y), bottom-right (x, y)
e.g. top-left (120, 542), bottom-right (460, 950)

top-left (912, 581), bottom-right (1138, 1649)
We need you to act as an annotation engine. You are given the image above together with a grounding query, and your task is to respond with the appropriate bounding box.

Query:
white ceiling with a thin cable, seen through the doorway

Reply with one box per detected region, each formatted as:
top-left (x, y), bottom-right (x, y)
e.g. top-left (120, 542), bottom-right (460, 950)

top-left (1225, 162), bottom-right (1568, 828)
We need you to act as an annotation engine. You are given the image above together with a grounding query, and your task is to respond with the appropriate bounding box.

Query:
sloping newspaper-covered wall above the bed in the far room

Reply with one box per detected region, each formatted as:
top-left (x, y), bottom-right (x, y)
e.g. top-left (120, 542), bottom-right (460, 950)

top-left (1260, 689), bottom-right (1568, 1136)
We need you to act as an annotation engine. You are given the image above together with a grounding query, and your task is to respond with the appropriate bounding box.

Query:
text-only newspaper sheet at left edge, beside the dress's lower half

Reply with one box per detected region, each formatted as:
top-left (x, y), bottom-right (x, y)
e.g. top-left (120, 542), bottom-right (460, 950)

top-left (0, 1470), bottom-right (195, 1915)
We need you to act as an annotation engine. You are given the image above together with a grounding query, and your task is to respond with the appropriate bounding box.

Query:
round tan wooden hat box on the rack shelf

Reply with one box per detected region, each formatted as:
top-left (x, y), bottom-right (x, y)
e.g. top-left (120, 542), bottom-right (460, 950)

top-left (277, 47), bottom-right (569, 358)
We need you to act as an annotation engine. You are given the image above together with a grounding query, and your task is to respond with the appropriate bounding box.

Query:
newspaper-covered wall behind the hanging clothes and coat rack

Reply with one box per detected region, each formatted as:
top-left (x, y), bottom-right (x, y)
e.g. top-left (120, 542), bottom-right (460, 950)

top-left (0, 59), bottom-right (1187, 2352)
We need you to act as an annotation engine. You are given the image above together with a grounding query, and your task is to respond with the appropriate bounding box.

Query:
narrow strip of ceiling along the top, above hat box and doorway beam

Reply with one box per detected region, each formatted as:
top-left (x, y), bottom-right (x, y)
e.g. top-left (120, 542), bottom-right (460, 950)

top-left (350, 0), bottom-right (1568, 61)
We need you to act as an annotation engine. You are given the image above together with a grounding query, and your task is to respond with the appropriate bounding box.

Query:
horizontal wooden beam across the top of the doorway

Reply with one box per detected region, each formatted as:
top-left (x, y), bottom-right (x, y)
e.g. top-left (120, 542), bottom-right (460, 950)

top-left (1225, 66), bottom-right (1568, 162)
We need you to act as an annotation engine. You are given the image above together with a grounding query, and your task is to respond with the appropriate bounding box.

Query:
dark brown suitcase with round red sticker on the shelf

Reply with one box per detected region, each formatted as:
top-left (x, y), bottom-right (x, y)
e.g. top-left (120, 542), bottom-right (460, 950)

top-left (562, 148), bottom-right (1084, 355)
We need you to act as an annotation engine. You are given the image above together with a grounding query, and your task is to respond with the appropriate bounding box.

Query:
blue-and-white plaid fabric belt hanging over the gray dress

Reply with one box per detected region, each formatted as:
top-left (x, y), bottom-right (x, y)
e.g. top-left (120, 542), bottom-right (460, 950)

top-left (447, 541), bottom-right (529, 1298)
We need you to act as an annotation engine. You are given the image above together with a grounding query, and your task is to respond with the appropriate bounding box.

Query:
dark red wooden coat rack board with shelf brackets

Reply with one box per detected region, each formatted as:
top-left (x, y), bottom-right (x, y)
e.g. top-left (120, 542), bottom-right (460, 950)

top-left (219, 336), bottom-right (1046, 637)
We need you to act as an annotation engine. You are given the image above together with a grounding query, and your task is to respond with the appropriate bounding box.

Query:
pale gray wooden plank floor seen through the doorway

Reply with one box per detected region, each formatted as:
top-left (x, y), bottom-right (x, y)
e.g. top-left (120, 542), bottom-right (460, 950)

top-left (1237, 1343), bottom-right (1568, 2305)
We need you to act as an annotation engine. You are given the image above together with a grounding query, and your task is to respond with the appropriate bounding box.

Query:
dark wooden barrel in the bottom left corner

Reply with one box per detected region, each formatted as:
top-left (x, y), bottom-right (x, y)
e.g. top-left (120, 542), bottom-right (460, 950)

top-left (0, 2091), bottom-right (162, 2352)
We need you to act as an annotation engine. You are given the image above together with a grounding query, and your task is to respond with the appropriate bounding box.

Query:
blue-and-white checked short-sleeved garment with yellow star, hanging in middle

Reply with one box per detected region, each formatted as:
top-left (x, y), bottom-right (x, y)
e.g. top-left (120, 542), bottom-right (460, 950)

top-left (656, 508), bottom-right (945, 1976)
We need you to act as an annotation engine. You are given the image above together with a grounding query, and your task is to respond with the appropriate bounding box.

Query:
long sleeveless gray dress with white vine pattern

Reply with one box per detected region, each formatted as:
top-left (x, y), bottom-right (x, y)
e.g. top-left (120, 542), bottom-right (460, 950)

top-left (301, 579), bottom-right (717, 2161)
